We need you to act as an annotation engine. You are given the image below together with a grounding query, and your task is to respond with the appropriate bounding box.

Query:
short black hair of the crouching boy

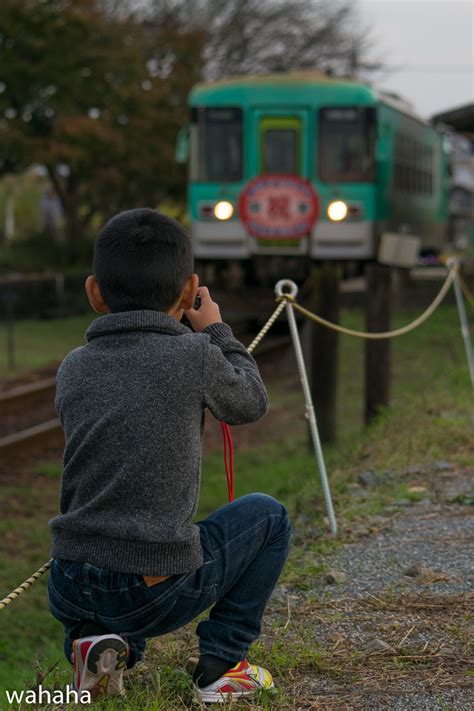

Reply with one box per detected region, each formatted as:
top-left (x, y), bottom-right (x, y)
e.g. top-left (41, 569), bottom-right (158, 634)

top-left (93, 208), bottom-right (194, 312)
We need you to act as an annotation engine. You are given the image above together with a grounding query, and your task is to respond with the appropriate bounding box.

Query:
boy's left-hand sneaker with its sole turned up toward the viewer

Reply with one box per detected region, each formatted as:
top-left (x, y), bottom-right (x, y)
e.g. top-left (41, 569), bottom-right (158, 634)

top-left (71, 634), bottom-right (129, 699)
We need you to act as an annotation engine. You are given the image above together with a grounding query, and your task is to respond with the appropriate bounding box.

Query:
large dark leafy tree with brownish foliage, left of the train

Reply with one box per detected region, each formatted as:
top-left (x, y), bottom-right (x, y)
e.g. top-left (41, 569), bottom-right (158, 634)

top-left (0, 0), bottom-right (204, 258)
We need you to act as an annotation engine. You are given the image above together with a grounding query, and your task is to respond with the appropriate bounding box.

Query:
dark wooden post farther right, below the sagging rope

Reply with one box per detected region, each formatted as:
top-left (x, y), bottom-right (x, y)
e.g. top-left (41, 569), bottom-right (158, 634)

top-left (365, 264), bottom-right (392, 424)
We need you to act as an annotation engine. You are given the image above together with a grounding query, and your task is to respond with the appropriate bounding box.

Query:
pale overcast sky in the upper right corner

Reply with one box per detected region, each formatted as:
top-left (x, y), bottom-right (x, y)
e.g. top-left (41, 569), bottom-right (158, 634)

top-left (355, 0), bottom-right (474, 117)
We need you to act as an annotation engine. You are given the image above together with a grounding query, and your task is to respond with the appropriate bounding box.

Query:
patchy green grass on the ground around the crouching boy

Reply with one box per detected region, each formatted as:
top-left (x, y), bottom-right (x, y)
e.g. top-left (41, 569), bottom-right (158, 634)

top-left (0, 307), bottom-right (474, 711)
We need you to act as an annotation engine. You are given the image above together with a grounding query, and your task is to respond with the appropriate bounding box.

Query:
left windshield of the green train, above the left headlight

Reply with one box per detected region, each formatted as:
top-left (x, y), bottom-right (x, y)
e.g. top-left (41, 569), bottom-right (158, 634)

top-left (191, 107), bottom-right (242, 182)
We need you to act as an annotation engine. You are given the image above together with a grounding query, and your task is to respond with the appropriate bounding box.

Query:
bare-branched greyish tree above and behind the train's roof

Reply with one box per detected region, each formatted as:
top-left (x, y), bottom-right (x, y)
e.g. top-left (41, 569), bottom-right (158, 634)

top-left (143, 0), bottom-right (380, 79)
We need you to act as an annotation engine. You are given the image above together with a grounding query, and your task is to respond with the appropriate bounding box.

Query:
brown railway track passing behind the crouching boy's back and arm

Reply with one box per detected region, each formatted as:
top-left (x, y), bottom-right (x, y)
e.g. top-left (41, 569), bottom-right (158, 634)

top-left (0, 324), bottom-right (291, 463)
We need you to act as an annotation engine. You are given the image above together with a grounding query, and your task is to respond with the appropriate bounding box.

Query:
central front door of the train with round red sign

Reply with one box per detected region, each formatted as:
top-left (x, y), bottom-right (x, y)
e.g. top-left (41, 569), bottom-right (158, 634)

top-left (239, 110), bottom-right (316, 266)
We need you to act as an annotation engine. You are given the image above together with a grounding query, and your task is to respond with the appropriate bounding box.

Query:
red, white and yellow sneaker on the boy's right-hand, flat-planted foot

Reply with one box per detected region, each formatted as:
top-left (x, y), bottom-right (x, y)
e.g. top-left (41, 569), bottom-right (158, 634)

top-left (196, 659), bottom-right (275, 704)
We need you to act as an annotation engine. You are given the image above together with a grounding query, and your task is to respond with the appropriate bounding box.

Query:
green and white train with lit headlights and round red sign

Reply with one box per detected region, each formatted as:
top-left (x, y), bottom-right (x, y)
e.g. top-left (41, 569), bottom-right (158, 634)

top-left (178, 72), bottom-right (447, 276)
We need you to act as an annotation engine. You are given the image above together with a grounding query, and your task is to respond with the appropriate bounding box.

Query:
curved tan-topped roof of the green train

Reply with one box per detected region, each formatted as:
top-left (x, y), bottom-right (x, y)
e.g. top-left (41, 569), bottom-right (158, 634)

top-left (190, 70), bottom-right (427, 124)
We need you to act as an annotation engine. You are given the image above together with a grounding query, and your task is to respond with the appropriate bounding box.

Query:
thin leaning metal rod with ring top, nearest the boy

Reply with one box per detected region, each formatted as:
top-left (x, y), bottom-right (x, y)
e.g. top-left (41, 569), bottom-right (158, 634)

top-left (275, 279), bottom-right (337, 535)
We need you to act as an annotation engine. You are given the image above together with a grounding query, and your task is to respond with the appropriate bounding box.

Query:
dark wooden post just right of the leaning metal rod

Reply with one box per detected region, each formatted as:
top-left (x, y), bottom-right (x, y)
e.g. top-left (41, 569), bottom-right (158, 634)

top-left (307, 263), bottom-right (341, 442)
